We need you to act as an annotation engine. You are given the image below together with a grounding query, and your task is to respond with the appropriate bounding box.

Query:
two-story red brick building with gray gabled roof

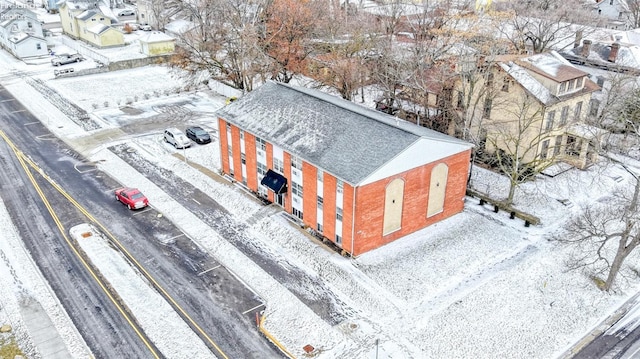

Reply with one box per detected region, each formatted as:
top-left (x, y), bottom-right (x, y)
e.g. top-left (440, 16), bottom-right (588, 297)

top-left (217, 82), bottom-right (471, 256)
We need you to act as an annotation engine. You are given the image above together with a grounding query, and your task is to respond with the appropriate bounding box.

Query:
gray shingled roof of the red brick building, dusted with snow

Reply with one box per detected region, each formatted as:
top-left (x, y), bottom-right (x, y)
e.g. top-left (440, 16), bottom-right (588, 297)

top-left (217, 82), bottom-right (470, 184)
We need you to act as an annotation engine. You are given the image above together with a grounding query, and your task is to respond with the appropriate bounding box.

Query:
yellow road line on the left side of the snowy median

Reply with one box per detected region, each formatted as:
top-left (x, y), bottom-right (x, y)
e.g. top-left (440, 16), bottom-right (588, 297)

top-left (0, 130), bottom-right (160, 358)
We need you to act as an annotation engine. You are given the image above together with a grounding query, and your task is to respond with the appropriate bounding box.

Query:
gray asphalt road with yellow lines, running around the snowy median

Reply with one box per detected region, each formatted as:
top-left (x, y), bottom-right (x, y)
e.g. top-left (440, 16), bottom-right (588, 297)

top-left (0, 84), bottom-right (282, 358)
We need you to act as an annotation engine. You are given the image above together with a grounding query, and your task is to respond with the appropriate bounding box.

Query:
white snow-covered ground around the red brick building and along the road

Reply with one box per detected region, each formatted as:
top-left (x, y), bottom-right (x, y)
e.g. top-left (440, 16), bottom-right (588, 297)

top-left (0, 32), bottom-right (640, 358)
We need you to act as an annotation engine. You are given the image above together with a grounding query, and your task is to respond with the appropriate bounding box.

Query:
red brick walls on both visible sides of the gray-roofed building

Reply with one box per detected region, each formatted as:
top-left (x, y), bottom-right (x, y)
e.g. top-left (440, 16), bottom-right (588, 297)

top-left (218, 118), bottom-right (470, 256)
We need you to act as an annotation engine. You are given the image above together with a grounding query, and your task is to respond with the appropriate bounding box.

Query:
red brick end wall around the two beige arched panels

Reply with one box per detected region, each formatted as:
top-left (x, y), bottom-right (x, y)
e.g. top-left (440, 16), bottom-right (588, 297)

top-left (345, 151), bottom-right (470, 256)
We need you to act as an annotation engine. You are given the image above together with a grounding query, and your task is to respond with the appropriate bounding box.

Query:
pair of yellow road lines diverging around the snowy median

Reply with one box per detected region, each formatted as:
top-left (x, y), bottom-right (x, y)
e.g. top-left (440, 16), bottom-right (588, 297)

top-left (0, 130), bottom-right (229, 359)
